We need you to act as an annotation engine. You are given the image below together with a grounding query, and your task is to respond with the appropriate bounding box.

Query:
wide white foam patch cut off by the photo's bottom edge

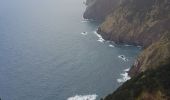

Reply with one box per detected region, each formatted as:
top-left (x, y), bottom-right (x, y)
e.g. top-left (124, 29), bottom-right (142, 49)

top-left (67, 94), bottom-right (97, 100)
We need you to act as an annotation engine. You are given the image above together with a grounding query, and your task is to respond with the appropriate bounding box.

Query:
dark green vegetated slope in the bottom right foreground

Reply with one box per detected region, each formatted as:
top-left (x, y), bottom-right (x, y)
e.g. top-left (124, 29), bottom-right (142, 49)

top-left (104, 62), bottom-right (170, 100)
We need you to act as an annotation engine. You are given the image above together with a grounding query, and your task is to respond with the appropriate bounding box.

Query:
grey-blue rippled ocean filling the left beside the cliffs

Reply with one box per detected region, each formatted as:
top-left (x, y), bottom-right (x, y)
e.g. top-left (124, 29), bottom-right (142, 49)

top-left (0, 0), bottom-right (140, 100)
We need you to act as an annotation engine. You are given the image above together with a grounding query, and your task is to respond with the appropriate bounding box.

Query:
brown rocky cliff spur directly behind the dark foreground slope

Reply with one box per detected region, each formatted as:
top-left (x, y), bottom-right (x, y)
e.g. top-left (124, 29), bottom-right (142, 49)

top-left (129, 33), bottom-right (170, 76)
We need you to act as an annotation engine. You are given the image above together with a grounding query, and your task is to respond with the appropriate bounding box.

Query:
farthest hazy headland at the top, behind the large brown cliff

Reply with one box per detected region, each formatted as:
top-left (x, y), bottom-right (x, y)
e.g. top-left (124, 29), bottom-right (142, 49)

top-left (83, 0), bottom-right (122, 20)
